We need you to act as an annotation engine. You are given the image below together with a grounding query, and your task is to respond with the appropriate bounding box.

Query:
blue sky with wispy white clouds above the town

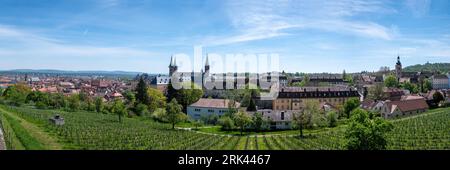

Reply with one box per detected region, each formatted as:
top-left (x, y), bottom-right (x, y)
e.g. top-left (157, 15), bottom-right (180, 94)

top-left (0, 0), bottom-right (450, 73)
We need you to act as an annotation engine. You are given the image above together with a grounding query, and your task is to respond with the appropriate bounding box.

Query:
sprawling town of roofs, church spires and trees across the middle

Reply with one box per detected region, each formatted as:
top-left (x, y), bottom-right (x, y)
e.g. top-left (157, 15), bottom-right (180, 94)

top-left (0, 56), bottom-right (450, 129)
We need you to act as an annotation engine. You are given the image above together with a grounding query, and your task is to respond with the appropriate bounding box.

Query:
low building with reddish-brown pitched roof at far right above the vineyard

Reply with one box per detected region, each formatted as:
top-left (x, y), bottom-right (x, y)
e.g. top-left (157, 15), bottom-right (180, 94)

top-left (381, 99), bottom-right (429, 119)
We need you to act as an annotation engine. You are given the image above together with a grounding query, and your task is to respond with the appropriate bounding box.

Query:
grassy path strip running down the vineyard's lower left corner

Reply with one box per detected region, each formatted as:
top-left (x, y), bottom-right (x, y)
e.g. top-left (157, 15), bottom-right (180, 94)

top-left (0, 108), bottom-right (63, 150)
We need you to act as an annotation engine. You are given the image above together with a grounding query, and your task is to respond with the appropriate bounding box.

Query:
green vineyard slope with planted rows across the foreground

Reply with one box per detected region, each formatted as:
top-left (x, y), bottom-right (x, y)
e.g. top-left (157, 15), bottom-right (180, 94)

top-left (0, 106), bottom-right (450, 150)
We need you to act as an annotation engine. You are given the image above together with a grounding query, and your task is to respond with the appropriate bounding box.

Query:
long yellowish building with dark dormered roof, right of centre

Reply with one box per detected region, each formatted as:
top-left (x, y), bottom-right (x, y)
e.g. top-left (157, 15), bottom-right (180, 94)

top-left (272, 86), bottom-right (360, 111)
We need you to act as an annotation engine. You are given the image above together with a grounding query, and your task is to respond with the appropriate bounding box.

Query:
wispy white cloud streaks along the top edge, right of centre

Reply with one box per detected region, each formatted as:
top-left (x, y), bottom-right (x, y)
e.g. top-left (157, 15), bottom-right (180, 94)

top-left (205, 0), bottom-right (397, 45)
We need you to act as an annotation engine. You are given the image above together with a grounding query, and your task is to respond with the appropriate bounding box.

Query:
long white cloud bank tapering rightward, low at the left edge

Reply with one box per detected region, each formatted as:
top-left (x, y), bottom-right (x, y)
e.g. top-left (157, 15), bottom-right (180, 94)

top-left (0, 25), bottom-right (154, 59)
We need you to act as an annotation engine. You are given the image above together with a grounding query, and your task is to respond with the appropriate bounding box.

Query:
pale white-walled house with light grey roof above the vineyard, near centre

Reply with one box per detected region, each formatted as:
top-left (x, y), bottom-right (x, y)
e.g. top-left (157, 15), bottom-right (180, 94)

top-left (187, 98), bottom-right (241, 119)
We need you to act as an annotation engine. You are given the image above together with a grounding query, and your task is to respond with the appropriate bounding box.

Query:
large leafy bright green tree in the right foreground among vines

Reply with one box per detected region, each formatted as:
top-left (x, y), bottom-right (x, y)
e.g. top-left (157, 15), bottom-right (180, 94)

top-left (345, 109), bottom-right (393, 150)
